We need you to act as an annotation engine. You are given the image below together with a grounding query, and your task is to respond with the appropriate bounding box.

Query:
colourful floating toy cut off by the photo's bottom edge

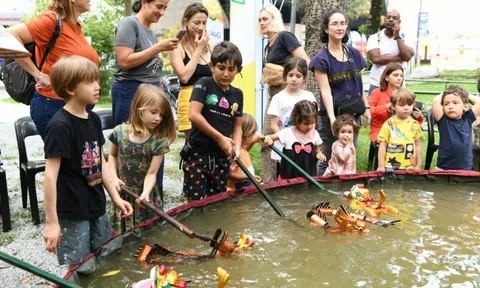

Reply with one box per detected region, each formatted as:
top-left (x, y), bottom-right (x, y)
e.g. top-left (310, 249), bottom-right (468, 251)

top-left (133, 265), bottom-right (187, 288)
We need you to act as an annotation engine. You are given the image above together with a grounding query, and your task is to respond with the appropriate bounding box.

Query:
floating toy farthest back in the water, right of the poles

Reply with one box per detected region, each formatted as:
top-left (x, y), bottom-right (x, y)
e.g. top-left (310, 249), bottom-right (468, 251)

top-left (344, 184), bottom-right (400, 217)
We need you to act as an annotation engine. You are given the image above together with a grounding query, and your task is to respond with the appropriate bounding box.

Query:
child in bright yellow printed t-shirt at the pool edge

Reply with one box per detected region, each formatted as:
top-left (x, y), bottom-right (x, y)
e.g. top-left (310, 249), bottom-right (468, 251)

top-left (377, 87), bottom-right (423, 171)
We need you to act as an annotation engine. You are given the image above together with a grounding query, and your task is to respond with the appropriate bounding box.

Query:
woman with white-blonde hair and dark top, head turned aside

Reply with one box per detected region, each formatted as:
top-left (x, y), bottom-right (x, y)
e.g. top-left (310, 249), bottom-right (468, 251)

top-left (258, 5), bottom-right (310, 183)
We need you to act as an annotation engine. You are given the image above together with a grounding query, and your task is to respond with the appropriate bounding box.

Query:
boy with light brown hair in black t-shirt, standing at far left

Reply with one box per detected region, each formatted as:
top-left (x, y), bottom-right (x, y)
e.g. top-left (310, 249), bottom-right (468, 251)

top-left (43, 56), bottom-right (133, 268)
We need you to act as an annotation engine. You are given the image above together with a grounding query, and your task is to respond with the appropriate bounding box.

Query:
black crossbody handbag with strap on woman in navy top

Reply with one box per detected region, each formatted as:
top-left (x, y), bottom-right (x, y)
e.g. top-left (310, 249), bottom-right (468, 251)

top-left (327, 45), bottom-right (366, 117)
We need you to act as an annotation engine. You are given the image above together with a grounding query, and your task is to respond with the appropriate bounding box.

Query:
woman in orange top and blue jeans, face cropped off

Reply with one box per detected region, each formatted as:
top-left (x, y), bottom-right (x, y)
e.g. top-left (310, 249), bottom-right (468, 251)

top-left (8, 0), bottom-right (99, 139)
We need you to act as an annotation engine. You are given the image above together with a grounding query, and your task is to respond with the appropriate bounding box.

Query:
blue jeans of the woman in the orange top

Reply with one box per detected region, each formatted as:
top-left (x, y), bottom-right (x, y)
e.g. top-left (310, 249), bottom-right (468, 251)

top-left (30, 91), bottom-right (95, 139)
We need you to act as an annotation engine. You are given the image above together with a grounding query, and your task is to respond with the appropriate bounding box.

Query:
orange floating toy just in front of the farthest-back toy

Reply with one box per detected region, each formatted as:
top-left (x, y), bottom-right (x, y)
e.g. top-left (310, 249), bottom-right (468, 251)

top-left (307, 203), bottom-right (370, 234)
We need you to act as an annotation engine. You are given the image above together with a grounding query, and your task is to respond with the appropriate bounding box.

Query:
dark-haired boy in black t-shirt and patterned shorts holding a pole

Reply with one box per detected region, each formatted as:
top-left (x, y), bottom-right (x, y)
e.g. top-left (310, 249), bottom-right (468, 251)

top-left (182, 41), bottom-right (243, 202)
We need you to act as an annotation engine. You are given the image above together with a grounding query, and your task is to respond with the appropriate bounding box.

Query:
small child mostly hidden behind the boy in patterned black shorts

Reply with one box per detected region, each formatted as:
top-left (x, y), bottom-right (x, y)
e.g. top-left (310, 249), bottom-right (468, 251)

top-left (227, 113), bottom-right (263, 191)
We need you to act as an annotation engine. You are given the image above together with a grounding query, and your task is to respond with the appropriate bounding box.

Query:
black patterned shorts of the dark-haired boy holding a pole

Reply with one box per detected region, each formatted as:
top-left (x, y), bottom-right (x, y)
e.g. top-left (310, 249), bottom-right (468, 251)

top-left (183, 152), bottom-right (230, 200)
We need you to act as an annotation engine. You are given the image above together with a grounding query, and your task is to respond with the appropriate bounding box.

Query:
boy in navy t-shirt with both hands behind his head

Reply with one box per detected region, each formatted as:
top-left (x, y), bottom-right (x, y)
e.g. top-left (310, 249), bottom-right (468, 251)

top-left (432, 85), bottom-right (480, 170)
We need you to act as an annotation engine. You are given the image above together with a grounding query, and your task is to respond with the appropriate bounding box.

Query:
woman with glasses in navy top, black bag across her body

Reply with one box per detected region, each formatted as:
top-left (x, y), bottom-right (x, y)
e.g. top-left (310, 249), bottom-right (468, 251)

top-left (309, 9), bottom-right (371, 175)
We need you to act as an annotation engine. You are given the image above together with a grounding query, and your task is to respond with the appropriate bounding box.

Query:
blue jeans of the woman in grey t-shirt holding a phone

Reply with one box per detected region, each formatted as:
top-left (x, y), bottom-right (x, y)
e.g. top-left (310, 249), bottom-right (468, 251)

top-left (111, 81), bottom-right (165, 189)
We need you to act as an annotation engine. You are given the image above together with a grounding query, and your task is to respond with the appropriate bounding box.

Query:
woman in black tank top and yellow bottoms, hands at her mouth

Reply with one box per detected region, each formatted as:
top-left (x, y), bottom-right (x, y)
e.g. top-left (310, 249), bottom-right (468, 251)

top-left (169, 3), bottom-right (213, 139)
